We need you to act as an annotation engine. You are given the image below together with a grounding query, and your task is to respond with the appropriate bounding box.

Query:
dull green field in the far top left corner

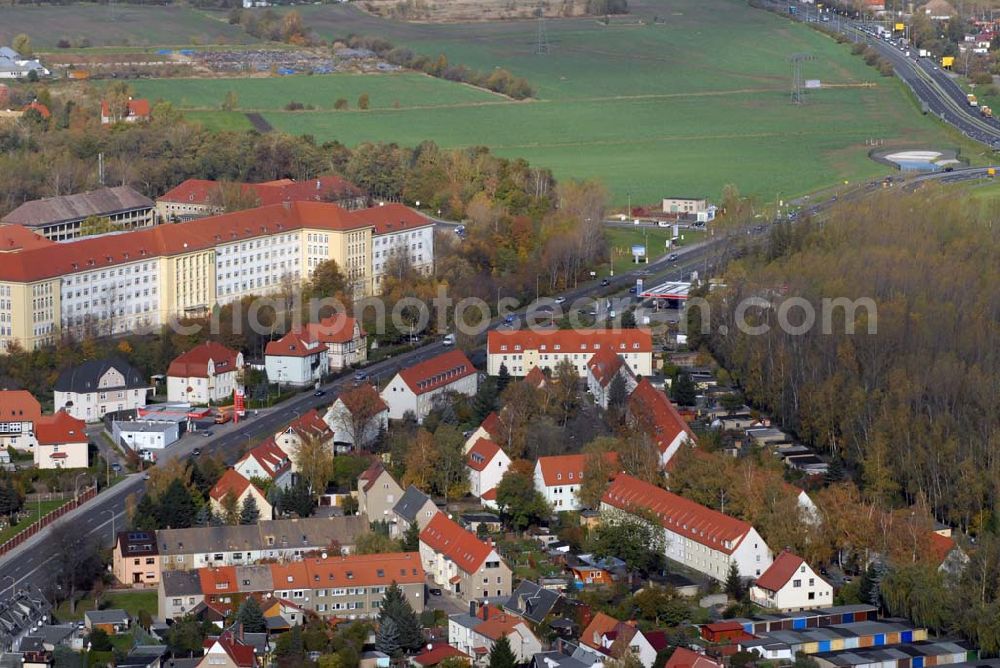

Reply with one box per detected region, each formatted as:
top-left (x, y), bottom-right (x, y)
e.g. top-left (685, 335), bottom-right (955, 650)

top-left (0, 3), bottom-right (257, 50)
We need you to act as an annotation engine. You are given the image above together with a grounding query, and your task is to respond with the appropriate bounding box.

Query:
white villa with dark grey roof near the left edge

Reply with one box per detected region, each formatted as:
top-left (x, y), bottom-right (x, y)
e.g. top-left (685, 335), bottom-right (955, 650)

top-left (55, 358), bottom-right (153, 422)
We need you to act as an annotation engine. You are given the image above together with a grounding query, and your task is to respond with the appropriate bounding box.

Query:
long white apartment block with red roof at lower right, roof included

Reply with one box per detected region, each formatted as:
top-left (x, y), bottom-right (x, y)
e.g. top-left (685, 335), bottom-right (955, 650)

top-left (601, 473), bottom-right (772, 582)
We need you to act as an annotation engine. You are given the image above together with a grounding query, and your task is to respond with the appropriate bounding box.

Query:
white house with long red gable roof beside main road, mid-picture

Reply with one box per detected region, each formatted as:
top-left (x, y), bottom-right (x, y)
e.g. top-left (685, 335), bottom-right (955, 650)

top-left (382, 350), bottom-right (479, 423)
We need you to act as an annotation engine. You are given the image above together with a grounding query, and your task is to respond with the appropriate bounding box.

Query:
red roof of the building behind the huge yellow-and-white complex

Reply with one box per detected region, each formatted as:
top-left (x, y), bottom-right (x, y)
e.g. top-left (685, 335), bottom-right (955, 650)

top-left (158, 176), bottom-right (364, 206)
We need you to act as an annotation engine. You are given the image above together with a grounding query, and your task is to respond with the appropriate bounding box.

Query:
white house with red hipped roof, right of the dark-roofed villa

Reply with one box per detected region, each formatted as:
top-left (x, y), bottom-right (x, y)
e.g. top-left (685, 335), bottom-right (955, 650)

top-left (167, 341), bottom-right (243, 405)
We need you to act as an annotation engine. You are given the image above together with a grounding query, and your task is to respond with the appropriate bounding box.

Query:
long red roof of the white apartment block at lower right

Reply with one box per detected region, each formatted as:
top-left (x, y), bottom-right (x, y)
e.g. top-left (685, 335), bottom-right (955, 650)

top-left (601, 474), bottom-right (753, 554)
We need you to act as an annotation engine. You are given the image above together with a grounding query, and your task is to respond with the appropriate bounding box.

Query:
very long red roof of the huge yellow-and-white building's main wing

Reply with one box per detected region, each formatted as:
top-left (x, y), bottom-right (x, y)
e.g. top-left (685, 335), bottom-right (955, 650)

top-left (0, 202), bottom-right (371, 282)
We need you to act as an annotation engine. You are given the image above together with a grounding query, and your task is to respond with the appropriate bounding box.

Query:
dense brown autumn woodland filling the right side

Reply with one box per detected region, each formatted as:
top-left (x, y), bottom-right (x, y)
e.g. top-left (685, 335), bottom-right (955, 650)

top-left (692, 186), bottom-right (1000, 652)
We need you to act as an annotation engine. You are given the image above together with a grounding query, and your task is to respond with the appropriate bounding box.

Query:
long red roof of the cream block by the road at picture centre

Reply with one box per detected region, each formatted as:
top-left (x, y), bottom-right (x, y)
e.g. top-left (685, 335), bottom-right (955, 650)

top-left (486, 328), bottom-right (653, 355)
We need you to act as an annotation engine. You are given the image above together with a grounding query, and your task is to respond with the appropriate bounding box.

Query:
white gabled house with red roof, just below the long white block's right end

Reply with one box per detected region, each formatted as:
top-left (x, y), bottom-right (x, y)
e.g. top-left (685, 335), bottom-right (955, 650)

top-left (750, 550), bottom-right (833, 612)
